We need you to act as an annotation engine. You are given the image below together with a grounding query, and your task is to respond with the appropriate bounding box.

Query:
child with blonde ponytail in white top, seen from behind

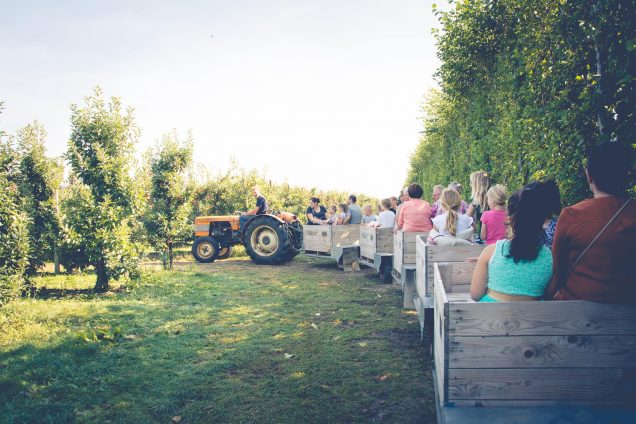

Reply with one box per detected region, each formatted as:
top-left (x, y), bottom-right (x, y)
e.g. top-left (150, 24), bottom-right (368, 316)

top-left (428, 188), bottom-right (473, 245)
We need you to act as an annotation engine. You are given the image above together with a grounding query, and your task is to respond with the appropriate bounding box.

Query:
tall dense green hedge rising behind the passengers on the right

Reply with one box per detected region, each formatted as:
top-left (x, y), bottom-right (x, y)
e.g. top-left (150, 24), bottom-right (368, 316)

top-left (408, 0), bottom-right (636, 204)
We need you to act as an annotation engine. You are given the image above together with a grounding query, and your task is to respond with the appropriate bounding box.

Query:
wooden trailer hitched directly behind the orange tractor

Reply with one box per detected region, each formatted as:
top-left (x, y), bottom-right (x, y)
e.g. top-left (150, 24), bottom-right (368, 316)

top-left (303, 224), bottom-right (360, 270)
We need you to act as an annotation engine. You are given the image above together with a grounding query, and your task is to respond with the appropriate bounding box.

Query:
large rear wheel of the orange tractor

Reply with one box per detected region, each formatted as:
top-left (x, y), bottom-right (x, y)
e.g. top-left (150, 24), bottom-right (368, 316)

top-left (243, 215), bottom-right (294, 265)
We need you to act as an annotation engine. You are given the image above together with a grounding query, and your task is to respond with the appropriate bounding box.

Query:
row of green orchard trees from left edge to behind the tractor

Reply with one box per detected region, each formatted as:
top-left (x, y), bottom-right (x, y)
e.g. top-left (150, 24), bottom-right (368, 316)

top-left (0, 88), bottom-right (377, 306)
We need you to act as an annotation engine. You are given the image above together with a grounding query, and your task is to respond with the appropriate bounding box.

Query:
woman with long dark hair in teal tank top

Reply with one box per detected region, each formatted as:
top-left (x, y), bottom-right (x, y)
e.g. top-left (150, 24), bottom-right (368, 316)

top-left (470, 186), bottom-right (552, 302)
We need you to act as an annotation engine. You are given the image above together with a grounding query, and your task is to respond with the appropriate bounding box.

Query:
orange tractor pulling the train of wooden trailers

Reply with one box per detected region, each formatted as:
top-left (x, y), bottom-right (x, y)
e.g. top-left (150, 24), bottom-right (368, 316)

top-left (192, 212), bottom-right (303, 265)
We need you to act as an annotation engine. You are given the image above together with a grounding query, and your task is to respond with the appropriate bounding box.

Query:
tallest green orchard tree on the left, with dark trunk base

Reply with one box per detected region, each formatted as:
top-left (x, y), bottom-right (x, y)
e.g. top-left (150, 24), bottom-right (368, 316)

top-left (64, 89), bottom-right (138, 291)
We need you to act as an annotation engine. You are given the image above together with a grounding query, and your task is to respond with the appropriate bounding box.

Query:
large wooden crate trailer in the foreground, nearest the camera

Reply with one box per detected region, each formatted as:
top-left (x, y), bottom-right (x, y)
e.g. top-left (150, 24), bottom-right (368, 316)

top-left (433, 262), bottom-right (636, 424)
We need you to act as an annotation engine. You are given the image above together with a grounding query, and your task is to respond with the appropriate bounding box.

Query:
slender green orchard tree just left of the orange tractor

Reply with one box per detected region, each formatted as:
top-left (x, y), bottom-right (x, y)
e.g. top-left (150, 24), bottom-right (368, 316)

top-left (144, 131), bottom-right (193, 269)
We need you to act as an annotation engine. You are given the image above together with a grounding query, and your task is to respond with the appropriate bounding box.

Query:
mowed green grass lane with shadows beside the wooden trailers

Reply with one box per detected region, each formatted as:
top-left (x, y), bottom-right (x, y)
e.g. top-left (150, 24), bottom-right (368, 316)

top-left (0, 257), bottom-right (435, 423)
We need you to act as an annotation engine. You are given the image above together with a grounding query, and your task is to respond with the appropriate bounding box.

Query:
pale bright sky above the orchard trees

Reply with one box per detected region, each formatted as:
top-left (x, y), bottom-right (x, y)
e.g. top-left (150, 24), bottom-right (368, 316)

top-left (0, 0), bottom-right (445, 197)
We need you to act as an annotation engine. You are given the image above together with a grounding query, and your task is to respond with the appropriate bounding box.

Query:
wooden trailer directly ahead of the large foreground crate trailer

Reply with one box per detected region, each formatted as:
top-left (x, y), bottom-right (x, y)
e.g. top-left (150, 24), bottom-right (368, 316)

top-left (413, 236), bottom-right (486, 334)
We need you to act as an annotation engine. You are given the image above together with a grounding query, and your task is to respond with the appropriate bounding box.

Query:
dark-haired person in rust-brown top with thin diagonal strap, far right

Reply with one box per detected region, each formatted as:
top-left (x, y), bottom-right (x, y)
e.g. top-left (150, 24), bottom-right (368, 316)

top-left (546, 142), bottom-right (636, 305)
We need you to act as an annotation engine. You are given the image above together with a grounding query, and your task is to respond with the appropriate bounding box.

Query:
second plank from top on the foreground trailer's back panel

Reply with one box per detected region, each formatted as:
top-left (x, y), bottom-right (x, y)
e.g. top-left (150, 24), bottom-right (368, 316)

top-left (448, 334), bottom-right (636, 368)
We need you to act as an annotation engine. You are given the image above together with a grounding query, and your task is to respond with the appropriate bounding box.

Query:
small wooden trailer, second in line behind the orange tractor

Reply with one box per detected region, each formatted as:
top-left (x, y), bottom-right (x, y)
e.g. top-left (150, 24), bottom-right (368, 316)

top-left (360, 225), bottom-right (393, 283)
